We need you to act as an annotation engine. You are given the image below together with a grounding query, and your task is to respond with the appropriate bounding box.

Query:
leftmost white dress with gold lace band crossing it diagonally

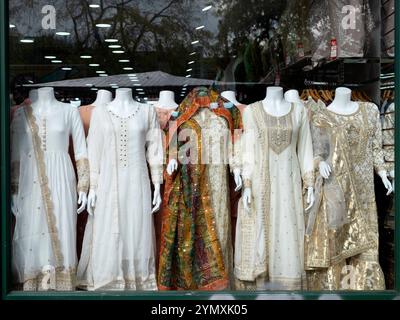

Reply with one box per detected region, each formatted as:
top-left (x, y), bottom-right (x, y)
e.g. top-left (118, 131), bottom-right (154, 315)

top-left (11, 104), bottom-right (89, 291)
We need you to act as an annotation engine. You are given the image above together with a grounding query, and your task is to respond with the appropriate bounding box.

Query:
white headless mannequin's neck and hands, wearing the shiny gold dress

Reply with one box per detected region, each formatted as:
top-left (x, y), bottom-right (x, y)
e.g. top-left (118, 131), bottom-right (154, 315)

top-left (319, 88), bottom-right (393, 195)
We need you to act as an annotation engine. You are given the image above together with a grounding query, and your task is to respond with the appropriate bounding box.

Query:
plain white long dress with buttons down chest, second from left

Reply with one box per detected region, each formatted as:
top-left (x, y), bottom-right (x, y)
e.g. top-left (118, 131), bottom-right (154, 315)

top-left (78, 103), bottom-right (163, 290)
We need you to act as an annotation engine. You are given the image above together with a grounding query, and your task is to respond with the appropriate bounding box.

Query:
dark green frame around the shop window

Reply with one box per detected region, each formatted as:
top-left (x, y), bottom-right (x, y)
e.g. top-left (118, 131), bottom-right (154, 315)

top-left (0, 1), bottom-right (400, 301)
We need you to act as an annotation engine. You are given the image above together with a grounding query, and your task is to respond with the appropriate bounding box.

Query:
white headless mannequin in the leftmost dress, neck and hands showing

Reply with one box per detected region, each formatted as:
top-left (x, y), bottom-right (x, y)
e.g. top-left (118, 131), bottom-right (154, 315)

top-left (12, 88), bottom-right (88, 214)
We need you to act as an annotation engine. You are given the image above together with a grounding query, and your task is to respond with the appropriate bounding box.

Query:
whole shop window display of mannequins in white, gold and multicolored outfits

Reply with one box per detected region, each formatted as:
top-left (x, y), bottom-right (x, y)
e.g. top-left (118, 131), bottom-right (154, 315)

top-left (2, 0), bottom-right (395, 295)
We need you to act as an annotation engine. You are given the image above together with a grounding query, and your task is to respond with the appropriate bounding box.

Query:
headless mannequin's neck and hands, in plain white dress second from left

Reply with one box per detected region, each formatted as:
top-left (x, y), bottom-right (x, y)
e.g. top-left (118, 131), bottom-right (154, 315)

top-left (87, 89), bottom-right (161, 215)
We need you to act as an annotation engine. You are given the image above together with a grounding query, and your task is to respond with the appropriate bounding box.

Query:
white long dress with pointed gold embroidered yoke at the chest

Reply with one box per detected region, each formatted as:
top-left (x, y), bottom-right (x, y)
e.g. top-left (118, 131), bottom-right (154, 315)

top-left (235, 102), bottom-right (313, 290)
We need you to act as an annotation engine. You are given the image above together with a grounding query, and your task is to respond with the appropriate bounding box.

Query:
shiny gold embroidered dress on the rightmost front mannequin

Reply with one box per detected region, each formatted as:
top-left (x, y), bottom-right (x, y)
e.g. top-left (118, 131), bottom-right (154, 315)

top-left (306, 102), bottom-right (385, 290)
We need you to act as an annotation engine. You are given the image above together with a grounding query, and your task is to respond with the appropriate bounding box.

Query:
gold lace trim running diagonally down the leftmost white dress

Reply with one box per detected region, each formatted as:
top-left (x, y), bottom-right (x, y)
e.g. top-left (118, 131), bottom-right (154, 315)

top-left (24, 105), bottom-right (64, 271)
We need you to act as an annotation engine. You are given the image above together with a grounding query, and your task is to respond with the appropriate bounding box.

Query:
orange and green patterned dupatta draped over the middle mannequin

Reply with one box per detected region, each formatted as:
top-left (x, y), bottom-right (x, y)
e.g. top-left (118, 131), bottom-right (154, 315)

top-left (158, 88), bottom-right (241, 290)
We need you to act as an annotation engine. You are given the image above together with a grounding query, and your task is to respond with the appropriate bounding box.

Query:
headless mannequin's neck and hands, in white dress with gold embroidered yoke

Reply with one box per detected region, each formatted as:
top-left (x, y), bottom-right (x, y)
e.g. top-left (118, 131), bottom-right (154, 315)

top-left (243, 87), bottom-right (315, 212)
